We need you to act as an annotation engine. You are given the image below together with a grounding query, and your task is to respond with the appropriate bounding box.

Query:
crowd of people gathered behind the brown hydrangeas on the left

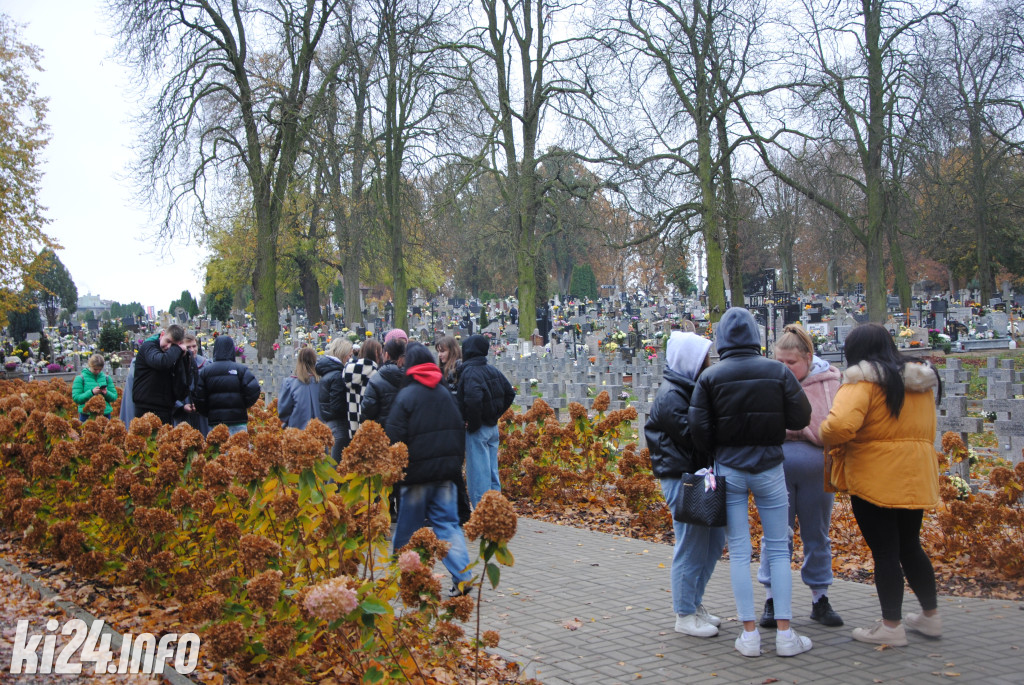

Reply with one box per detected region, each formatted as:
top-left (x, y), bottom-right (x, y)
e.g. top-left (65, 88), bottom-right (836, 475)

top-left (79, 325), bottom-right (515, 595)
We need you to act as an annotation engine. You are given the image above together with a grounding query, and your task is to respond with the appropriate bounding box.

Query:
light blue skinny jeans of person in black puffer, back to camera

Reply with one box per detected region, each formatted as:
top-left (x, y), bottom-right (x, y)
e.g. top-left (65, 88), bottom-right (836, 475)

top-left (715, 464), bottom-right (793, 620)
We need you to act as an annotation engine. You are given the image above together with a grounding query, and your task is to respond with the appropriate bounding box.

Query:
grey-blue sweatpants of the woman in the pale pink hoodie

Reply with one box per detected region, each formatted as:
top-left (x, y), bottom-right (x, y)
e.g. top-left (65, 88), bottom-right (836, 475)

top-left (758, 441), bottom-right (836, 590)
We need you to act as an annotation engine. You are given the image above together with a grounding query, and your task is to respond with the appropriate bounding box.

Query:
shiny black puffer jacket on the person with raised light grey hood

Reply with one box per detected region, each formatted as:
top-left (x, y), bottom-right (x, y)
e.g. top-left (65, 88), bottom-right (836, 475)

top-left (643, 369), bottom-right (711, 478)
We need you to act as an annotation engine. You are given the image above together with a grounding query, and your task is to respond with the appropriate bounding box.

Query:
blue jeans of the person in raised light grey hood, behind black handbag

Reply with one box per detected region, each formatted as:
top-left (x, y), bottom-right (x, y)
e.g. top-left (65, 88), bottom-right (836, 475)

top-left (662, 478), bottom-right (725, 616)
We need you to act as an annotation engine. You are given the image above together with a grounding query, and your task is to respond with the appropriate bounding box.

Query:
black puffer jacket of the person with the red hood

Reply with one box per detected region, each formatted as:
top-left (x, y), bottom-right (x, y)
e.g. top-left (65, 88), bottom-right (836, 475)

top-left (385, 374), bottom-right (466, 485)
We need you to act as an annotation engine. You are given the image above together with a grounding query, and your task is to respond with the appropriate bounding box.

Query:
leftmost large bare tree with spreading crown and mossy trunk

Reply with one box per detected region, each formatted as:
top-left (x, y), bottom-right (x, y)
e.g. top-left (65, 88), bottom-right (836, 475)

top-left (111, 0), bottom-right (350, 358)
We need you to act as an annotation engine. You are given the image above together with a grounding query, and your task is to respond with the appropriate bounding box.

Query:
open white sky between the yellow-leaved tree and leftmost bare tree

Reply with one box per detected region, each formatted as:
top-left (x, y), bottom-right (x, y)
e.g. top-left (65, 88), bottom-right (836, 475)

top-left (0, 0), bottom-right (206, 310)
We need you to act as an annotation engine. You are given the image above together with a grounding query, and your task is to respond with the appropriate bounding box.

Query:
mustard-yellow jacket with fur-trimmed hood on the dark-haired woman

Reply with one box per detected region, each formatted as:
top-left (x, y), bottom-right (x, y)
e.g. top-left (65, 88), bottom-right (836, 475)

top-left (819, 361), bottom-right (939, 509)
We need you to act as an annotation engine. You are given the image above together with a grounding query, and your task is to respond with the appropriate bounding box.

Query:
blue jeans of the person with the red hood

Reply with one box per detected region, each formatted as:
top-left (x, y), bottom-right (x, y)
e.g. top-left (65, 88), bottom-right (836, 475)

top-left (393, 480), bottom-right (473, 583)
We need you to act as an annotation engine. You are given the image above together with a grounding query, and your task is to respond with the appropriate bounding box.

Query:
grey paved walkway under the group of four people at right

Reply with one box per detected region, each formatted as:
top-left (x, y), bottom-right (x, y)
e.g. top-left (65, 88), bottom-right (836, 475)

top-left (483, 518), bottom-right (1024, 685)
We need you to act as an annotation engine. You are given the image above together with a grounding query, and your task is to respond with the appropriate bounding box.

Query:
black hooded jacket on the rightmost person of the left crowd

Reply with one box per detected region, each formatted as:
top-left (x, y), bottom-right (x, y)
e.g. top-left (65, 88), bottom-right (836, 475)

top-left (458, 335), bottom-right (515, 433)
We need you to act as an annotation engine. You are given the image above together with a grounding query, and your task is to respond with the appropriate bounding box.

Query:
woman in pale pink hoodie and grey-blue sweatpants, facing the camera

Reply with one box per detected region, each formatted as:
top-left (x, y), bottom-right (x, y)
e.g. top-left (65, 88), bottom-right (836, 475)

top-left (758, 324), bottom-right (843, 628)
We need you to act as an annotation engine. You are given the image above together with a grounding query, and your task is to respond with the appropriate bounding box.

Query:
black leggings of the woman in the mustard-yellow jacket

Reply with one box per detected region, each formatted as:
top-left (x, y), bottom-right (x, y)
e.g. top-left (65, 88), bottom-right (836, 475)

top-left (850, 496), bottom-right (938, 622)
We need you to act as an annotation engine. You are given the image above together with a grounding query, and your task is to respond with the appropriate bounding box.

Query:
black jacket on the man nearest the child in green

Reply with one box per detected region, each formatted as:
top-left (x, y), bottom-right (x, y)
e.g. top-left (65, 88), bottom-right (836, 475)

top-left (132, 336), bottom-right (191, 413)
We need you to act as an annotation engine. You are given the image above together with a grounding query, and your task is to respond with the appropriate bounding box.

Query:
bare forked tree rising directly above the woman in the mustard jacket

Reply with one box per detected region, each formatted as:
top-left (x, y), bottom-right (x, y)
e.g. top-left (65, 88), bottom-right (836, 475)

top-left (744, 0), bottom-right (950, 322)
